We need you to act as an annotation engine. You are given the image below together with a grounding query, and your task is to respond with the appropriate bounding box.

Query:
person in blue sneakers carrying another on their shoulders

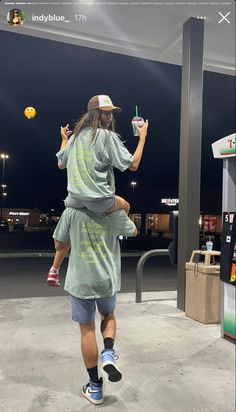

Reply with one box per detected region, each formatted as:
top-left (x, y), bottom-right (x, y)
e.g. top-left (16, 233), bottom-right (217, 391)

top-left (53, 207), bottom-right (137, 405)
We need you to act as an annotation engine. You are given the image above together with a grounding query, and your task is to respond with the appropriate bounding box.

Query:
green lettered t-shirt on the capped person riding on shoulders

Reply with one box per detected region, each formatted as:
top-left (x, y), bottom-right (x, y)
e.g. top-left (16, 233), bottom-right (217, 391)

top-left (57, 128), bottom-right (133, 200)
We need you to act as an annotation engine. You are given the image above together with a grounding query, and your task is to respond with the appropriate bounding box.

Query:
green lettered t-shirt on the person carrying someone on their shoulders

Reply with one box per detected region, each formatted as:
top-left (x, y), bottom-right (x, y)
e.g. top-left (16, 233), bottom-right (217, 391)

top-left (53, 208), bottom-right (136, 299)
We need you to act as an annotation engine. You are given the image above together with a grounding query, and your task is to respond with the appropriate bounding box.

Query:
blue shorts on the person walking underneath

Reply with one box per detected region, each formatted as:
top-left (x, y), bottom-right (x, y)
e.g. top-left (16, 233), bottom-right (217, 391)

top-left (71, 294), bottom-right (116, 323)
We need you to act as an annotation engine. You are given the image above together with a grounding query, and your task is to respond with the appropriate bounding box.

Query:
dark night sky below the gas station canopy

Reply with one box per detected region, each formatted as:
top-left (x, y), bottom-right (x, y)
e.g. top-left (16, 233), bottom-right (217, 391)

top-left (0, 31), bottom-right (235, 213)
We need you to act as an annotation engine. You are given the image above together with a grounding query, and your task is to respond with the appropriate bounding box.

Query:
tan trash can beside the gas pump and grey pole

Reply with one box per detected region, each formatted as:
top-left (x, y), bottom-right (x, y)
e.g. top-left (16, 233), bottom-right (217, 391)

top-left (185, 250), bottom-right (220, 323)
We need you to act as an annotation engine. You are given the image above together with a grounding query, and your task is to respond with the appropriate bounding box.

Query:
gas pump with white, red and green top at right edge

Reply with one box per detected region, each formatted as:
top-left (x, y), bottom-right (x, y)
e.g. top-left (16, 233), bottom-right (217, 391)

top-left (212, 133), bottom-right (236, 341)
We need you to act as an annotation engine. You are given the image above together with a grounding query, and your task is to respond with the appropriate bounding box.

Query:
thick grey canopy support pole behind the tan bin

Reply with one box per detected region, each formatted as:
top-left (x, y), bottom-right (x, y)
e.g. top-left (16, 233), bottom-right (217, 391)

top-left (177, 17), bottom-right (204, 310)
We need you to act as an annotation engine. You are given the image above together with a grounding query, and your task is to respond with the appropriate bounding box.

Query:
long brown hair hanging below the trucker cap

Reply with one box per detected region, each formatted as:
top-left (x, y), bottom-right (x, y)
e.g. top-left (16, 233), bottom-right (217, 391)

top-left (73, 110), bottom-right (115, 141)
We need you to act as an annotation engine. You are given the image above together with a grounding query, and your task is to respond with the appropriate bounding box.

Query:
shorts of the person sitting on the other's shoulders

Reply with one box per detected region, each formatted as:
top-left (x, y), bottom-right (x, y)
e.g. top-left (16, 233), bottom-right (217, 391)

top-left (64, 194), bottom-right (115, 215)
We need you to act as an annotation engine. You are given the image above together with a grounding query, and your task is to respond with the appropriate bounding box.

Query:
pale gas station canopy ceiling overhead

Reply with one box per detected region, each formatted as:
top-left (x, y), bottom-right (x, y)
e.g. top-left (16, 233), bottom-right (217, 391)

top-left (0, 0), bottom-right (235, 75)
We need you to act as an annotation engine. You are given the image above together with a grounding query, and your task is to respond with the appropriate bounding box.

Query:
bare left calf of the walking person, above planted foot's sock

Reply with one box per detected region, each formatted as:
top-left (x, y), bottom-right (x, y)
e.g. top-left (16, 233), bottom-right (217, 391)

top-left (80, 322), bottom-right (98, 369)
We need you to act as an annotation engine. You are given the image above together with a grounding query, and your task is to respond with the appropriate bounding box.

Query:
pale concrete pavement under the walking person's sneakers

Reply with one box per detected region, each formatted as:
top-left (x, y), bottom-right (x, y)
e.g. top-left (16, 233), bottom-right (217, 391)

top-left (0, 291), bottom-right (235, 412)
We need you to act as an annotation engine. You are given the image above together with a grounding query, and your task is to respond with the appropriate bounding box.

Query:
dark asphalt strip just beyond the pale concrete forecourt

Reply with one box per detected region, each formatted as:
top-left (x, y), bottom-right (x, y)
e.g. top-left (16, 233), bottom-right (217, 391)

top-left (0, 256), bottom-right (177, 299)
